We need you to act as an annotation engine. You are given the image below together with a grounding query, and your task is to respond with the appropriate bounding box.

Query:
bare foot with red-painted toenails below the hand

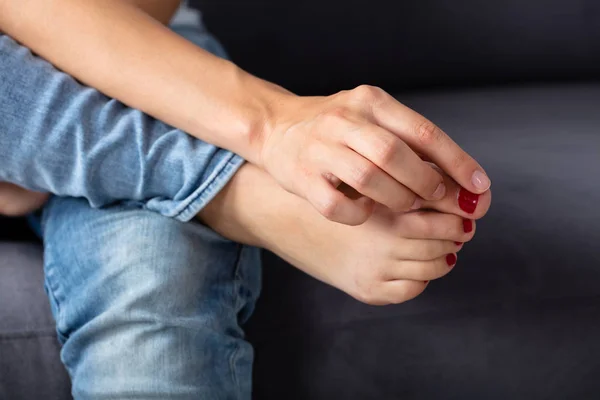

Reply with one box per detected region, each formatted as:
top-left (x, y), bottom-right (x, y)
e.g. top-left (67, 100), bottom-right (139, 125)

top-left (199, 164), bottom-right (491, 305)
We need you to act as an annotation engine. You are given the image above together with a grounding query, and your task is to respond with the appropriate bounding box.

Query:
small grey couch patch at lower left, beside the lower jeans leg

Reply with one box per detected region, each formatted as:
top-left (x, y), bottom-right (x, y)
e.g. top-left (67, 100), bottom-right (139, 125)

top-left (0, 242), bottom-right (70, 400)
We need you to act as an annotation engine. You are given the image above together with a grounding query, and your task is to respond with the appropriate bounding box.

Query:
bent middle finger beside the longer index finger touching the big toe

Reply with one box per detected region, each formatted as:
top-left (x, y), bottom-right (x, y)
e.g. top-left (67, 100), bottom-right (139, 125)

top-left (344, 123), bottom-right (445, 200)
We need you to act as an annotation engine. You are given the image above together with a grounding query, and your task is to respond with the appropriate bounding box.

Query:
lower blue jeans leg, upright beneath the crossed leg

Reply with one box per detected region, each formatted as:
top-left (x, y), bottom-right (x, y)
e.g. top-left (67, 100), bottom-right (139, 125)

top-left (42, 197), bottom-right (261, 400)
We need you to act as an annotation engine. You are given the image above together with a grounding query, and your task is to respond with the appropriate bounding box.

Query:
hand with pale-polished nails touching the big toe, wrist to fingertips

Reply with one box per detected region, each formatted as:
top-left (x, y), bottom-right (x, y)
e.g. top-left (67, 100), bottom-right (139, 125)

top-left (259, 86), bottom-right (490, 225)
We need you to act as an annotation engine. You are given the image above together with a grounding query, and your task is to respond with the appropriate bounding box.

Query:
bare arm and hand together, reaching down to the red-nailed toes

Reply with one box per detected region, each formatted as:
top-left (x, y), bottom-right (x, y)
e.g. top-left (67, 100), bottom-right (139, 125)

top-left (0, 0), bottom-right (490, 225)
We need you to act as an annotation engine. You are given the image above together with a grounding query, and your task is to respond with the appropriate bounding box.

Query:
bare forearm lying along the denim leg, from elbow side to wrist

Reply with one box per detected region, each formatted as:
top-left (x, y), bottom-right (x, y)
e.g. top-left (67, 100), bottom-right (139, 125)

top-left (0, 0), bottom-right (284, 162)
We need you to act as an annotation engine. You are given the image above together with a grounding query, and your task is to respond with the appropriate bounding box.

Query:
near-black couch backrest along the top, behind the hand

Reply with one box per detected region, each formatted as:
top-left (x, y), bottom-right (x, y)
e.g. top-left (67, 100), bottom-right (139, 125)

top-left (191, 0), bottom-right (600, 94)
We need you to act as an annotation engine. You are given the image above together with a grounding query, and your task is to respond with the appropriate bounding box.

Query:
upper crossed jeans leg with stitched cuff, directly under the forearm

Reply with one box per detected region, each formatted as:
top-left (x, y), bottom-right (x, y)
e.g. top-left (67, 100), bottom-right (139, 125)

top-left (0, 35), bottom-right (243, 220)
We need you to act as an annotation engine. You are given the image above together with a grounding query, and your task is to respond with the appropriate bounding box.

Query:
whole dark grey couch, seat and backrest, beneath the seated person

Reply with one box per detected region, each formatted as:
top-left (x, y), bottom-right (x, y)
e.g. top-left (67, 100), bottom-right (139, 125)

top-left (0, 0), bottom-right (600, 400)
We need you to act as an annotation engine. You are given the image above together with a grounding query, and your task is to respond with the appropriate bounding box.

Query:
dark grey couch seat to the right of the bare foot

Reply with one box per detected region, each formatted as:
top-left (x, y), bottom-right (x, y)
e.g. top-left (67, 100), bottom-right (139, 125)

top-left (248, 85), bottom-right (600, 400)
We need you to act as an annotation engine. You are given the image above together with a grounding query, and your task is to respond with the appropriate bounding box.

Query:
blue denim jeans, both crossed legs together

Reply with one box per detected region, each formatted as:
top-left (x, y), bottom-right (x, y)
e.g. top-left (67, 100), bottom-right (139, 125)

top-left (0, 16), bottom-right (261, 400)
